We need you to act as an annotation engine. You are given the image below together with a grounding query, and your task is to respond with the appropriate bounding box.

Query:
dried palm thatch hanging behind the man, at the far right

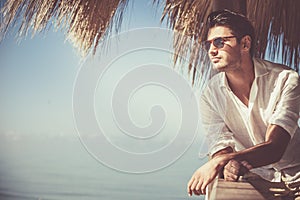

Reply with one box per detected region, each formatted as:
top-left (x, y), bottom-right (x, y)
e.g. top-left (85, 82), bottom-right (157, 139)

top-left (247, 0), bottom-right (300, 72)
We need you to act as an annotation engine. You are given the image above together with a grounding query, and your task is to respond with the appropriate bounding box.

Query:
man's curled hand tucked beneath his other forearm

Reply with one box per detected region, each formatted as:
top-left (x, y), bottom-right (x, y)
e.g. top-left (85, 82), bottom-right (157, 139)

top-left (223, 160), bottom-right (252, 181)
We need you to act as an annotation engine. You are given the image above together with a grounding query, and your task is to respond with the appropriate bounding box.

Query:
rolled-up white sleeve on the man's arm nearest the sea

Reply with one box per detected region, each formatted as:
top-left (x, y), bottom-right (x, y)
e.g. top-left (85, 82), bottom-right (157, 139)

top-left (200, 90), bottom-right (235, 156)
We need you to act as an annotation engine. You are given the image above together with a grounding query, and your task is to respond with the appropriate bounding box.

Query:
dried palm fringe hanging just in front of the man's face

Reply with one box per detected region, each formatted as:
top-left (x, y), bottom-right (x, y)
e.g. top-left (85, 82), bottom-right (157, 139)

top-left (162, 0), bottom-right (212, 85)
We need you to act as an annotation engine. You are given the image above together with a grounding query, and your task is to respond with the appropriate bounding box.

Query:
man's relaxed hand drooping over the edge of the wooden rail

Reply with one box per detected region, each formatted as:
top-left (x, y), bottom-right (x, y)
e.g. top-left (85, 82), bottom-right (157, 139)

top-left (187, 155), bottom-right (227, 196)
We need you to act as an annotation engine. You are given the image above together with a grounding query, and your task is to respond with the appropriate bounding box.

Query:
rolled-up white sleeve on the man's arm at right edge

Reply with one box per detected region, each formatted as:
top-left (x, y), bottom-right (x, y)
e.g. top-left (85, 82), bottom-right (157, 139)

top-left (269, 71), bottom-right (300, 137)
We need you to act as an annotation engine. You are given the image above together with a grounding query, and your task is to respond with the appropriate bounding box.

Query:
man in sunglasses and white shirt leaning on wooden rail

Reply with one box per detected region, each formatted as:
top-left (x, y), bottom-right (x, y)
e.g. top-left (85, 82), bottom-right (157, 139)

top-left (187, 10), bottom-right (300, 195)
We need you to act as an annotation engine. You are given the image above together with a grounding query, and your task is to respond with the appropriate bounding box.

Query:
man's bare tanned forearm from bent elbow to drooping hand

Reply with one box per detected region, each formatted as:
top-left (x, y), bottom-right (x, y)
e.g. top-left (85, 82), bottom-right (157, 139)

top-left (187, 125), bottom-right (290, 195)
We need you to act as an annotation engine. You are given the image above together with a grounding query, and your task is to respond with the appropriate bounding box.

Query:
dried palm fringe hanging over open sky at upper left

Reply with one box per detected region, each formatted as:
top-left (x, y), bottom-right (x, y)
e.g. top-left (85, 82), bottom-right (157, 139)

top-left (0, 0), bottom-right (128, 55)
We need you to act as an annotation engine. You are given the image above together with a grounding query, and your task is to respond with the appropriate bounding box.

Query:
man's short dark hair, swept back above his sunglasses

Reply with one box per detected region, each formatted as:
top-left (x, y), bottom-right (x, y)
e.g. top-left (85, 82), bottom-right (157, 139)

top-left (206, 10), bottom-right (255, 56)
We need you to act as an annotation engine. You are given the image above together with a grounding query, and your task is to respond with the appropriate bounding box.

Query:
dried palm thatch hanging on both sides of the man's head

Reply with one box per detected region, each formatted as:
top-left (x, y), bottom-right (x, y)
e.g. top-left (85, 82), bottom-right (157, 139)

top-left (162, 0), bottom-right (300, 83)
